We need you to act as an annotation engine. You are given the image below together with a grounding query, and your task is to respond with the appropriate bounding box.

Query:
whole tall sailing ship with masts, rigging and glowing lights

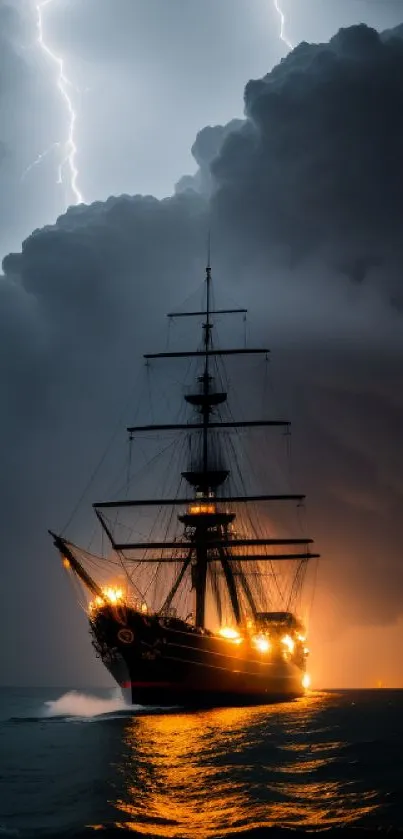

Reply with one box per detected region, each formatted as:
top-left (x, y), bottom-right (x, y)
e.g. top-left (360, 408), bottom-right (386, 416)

top-left (49, 259), bottom-right (319, 707)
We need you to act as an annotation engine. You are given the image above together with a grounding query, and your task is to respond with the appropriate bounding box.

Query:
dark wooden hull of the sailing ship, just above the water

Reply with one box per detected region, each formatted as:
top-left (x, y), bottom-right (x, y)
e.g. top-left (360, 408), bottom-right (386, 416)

top-left (91, 608), bottom-right (304, 707)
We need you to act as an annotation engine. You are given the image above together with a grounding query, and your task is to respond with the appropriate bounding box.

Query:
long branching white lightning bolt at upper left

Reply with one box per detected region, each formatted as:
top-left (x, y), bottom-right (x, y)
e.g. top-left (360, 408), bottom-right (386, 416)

top-left (36, 0), bottom-right (84, 204)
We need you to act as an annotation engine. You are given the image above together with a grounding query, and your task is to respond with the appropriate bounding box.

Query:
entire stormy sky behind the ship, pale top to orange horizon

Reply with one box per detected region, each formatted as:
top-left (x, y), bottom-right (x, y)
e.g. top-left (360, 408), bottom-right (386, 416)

top-left (0, 0), bottom-right (403, 687)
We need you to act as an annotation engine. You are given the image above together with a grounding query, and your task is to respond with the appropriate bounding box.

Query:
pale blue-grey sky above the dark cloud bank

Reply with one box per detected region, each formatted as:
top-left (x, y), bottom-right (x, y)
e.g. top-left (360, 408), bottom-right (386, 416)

top-left (0, 0), bottom-right (402, 249)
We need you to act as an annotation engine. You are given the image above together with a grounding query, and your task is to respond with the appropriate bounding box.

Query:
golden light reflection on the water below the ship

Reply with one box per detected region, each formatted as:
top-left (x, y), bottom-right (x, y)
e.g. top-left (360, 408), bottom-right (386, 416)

top-left (115, 694), bottom-right (377, 839)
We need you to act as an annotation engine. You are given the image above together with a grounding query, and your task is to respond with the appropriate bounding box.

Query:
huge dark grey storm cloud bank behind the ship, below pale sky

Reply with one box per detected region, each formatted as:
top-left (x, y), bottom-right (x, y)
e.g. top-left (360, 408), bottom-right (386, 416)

top-left (0, 27), bottom-right (403, 682)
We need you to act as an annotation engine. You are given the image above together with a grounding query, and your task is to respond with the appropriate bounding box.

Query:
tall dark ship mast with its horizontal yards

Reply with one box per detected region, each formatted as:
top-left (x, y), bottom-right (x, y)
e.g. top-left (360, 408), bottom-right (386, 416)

top-left (93, 258), bottom-right (318, 628)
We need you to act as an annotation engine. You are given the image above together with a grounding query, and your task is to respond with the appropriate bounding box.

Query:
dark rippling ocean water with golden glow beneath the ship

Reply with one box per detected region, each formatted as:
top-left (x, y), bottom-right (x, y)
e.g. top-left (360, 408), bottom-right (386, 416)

top-left (0, 688), bottom-right (403, 839)
